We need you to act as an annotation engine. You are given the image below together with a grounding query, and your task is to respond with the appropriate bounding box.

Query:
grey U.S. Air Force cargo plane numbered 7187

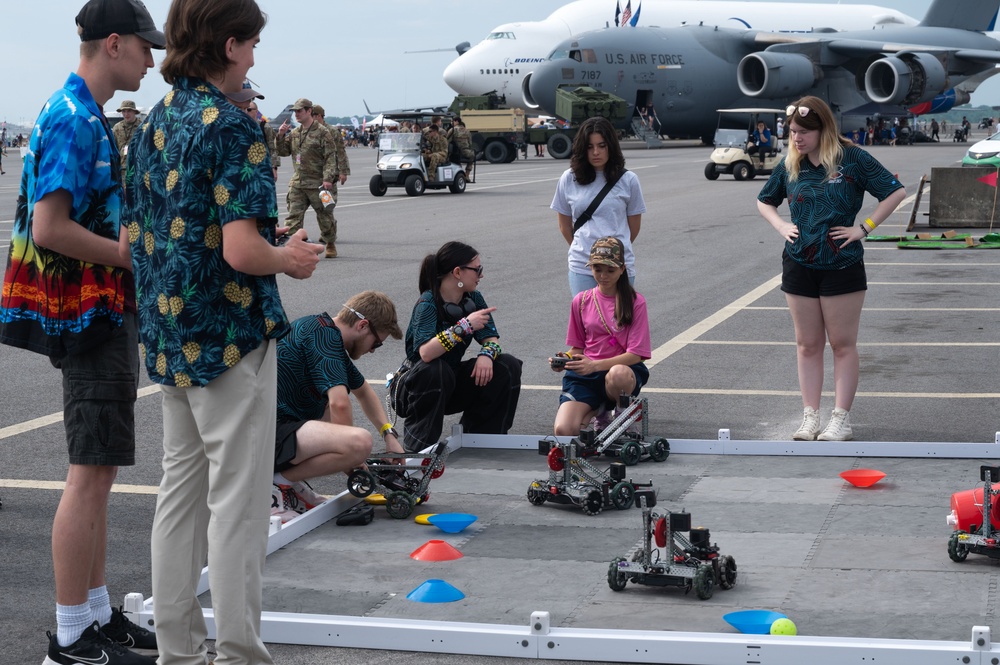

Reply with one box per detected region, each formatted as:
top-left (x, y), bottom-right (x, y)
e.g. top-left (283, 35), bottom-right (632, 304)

top-left (525, 0), bottom-right (1000, 142)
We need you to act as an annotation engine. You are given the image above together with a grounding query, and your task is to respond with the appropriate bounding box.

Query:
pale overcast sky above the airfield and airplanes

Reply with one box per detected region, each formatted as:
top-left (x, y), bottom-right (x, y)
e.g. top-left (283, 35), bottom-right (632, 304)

top-left (0, 0), bottom-right (976, 124)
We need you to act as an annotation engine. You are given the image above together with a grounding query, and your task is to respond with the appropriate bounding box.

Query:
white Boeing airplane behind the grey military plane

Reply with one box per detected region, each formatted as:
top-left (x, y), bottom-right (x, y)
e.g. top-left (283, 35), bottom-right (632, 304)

top-left (444, 0), bottom-right (917, 108)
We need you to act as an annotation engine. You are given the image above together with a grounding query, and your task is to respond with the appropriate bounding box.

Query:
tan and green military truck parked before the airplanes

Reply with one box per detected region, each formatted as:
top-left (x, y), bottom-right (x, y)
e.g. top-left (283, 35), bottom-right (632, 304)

top-left (448, 86), bottom-right (628, 164)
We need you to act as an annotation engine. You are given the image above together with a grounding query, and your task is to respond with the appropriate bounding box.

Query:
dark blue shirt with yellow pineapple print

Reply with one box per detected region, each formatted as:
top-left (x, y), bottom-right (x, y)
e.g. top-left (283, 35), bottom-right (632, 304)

top-left (125, 78), bottom-right (288, 387)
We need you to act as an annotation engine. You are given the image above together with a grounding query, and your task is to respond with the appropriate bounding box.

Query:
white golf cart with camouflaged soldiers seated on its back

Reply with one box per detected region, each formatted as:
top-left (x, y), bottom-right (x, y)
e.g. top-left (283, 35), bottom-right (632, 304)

top-left (368, 114), bottom-right (475, 196)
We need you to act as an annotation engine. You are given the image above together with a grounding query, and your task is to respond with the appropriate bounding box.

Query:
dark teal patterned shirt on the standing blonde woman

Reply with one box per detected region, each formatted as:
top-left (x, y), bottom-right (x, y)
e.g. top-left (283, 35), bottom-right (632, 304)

top-left (757, 146), bottom-right (903, 270)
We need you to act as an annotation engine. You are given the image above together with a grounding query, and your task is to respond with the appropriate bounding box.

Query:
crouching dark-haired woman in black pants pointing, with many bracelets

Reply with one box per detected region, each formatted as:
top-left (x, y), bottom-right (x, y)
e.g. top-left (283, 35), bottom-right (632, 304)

top-left (390, 242), bottom-right (521, 452)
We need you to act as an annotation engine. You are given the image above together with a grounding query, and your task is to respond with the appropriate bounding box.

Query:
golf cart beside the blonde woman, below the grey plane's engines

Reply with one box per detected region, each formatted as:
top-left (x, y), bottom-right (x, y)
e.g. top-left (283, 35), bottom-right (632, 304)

top-left (705, 108), bottom-right (785, 180)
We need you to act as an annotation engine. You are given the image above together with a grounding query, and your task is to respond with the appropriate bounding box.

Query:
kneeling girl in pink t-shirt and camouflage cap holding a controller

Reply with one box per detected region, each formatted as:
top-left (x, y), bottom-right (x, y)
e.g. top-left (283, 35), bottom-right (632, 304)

top-left (549, 237), bottom-right (650, 436)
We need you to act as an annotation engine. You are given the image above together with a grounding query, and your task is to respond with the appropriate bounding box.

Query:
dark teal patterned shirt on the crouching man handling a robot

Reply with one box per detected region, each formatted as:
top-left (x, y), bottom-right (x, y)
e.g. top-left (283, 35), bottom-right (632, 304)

top-left (278, 312), bottom-right (365, 422)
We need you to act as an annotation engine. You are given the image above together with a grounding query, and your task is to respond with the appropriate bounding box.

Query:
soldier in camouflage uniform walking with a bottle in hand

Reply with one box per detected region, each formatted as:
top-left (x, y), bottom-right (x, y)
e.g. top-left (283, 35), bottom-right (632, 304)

top-left (277, 97), bottom-right (340, 259)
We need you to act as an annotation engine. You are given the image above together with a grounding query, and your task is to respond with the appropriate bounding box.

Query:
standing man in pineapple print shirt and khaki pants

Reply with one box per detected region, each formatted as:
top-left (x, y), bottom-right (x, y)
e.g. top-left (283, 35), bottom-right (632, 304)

top-left (125, 0), bottom-right (322, 664)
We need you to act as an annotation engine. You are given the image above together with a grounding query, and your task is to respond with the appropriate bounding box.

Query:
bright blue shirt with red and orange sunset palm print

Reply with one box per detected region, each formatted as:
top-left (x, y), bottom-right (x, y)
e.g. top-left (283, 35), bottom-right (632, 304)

top-left (0, 74), bottom-right (135, 358)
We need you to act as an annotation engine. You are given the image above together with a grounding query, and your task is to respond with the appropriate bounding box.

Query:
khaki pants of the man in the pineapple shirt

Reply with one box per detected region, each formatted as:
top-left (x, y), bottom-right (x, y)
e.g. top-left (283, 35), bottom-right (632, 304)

top-left (151, 340), bottom-right (277, 665)
